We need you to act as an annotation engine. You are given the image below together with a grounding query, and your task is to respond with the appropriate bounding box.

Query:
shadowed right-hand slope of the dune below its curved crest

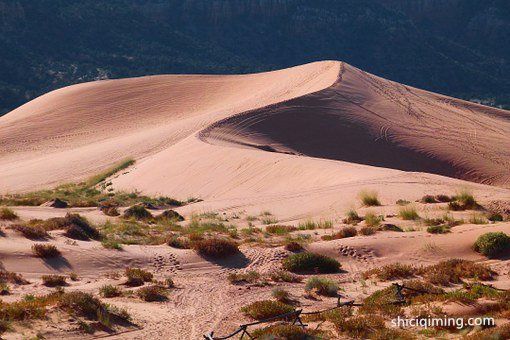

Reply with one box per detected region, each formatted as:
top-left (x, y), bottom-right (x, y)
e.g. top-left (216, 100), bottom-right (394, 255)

top-left (200, 64), bottom-right (510, 186)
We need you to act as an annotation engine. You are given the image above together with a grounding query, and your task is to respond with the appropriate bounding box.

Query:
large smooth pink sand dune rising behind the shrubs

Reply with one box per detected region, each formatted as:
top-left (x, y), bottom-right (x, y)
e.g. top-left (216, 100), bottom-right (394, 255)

top-left (0, 61), bottom-right (510, 218)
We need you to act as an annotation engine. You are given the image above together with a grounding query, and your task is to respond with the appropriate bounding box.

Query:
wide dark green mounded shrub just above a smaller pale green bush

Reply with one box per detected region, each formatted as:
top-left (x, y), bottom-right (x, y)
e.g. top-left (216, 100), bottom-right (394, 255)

top-left (283, 253), bottom-right (340, 273)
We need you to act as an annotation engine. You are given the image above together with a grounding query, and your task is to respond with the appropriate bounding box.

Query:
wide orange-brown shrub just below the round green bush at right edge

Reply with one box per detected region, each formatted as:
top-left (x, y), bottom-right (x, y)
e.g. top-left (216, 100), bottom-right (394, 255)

top-left (420, 259), bottom-right (496, 286)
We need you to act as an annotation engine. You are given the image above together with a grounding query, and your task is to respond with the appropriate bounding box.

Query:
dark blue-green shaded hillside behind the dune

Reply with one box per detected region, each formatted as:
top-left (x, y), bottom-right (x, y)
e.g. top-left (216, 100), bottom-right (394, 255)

top-left (0, 0), bottom-right (510, 114)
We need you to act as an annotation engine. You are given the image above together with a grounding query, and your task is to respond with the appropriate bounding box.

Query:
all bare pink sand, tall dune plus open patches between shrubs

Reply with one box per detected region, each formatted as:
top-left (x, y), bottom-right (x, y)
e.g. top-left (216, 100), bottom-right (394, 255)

top-left (0, 61), bottom-right (510, 339)
